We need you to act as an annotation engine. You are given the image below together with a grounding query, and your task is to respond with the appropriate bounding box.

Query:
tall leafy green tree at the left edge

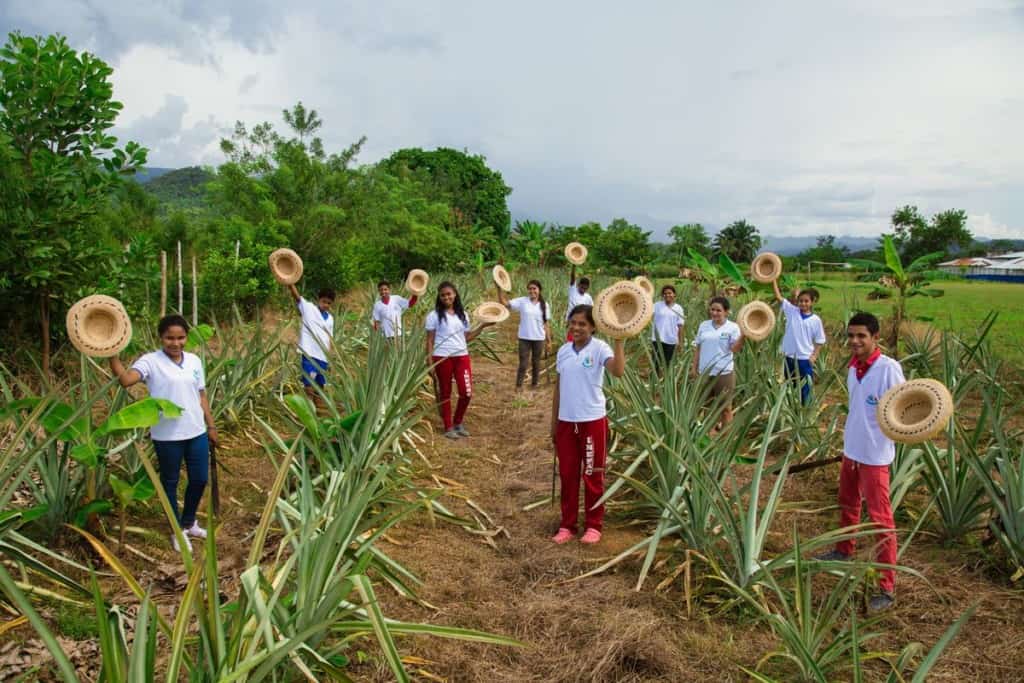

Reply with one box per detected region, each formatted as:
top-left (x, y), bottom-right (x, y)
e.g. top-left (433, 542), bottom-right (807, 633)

top-left (0, 33), bottom-right (146, 371)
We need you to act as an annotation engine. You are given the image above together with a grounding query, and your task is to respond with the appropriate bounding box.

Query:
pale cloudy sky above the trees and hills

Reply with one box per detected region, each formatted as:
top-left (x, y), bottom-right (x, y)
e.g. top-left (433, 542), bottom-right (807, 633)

top-left (0, 0), bottom-right (1024, 238)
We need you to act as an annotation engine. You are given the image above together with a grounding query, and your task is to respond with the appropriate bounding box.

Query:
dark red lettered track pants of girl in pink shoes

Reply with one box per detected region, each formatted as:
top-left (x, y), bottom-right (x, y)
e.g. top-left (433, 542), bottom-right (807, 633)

top-left (555, 418), bottom-right (608, 533)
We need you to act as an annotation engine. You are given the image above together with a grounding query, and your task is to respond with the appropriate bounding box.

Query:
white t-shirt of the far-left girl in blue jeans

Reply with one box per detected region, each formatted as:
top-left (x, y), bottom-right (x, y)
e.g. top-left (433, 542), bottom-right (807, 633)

top-left (131, 349), bottom-right (206, 441)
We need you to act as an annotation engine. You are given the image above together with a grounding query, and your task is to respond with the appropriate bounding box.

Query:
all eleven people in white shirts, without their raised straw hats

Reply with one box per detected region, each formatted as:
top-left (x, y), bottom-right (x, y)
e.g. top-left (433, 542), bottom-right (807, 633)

top-left (110, 255), bottom-right (904, 608)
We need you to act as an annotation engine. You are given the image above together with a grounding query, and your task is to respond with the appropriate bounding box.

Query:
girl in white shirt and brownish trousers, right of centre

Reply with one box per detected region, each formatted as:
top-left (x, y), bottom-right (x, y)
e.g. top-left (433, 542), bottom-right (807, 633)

top-left (693, 296), bottom-right (743, 428)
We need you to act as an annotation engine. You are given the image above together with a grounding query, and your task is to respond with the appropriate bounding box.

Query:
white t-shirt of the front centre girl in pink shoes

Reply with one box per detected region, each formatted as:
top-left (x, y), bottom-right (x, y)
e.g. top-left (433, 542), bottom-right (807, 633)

top-left (555, 337), bottom-right (614, 422)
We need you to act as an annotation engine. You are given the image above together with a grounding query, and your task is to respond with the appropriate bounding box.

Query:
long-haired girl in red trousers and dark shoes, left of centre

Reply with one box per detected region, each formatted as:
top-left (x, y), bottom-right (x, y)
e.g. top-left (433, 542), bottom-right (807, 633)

top-left (424, 282), bottom-right (500, 439)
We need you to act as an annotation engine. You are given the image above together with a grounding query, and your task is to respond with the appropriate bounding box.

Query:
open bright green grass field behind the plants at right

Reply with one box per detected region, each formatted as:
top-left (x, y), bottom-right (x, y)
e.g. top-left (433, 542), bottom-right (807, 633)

top-left (817, 279), bottom-right (1024, 368)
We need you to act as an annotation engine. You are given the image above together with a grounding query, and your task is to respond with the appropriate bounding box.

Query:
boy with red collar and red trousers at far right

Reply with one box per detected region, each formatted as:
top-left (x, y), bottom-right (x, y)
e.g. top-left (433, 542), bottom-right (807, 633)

top-left (817, 312), bottom-right (906, 611)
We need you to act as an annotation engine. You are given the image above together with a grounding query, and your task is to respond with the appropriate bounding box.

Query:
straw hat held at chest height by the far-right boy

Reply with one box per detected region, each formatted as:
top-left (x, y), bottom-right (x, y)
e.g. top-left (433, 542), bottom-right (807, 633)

top-left (874, 379), bottom-right (953, 443)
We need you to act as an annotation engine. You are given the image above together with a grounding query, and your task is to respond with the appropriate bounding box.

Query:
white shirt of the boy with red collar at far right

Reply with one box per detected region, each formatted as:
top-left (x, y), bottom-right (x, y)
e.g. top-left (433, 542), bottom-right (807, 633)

top-left (843, 354), bottom-right (906, 465)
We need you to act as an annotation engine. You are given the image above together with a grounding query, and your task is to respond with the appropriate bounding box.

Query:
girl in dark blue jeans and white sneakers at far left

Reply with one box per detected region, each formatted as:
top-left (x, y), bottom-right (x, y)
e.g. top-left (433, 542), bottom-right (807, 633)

top-left (110, 315), bottom-right (217, 550)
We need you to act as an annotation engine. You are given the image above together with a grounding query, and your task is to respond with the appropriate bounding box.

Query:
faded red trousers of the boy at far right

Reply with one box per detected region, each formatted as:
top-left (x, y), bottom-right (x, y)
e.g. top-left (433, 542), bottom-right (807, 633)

top-left (836, 456), bottom-right (896, 593)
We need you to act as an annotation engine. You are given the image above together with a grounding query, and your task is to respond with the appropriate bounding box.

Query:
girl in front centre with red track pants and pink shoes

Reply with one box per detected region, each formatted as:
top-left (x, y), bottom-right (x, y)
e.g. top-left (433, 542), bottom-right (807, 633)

top-left (551, 304), bottom-right (626, 544)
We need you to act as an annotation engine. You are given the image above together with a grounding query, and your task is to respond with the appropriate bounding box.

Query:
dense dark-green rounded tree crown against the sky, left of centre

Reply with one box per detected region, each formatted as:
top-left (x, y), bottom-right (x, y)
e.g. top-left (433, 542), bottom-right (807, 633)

top-left (381, 147), bottom-right (512, 241)
